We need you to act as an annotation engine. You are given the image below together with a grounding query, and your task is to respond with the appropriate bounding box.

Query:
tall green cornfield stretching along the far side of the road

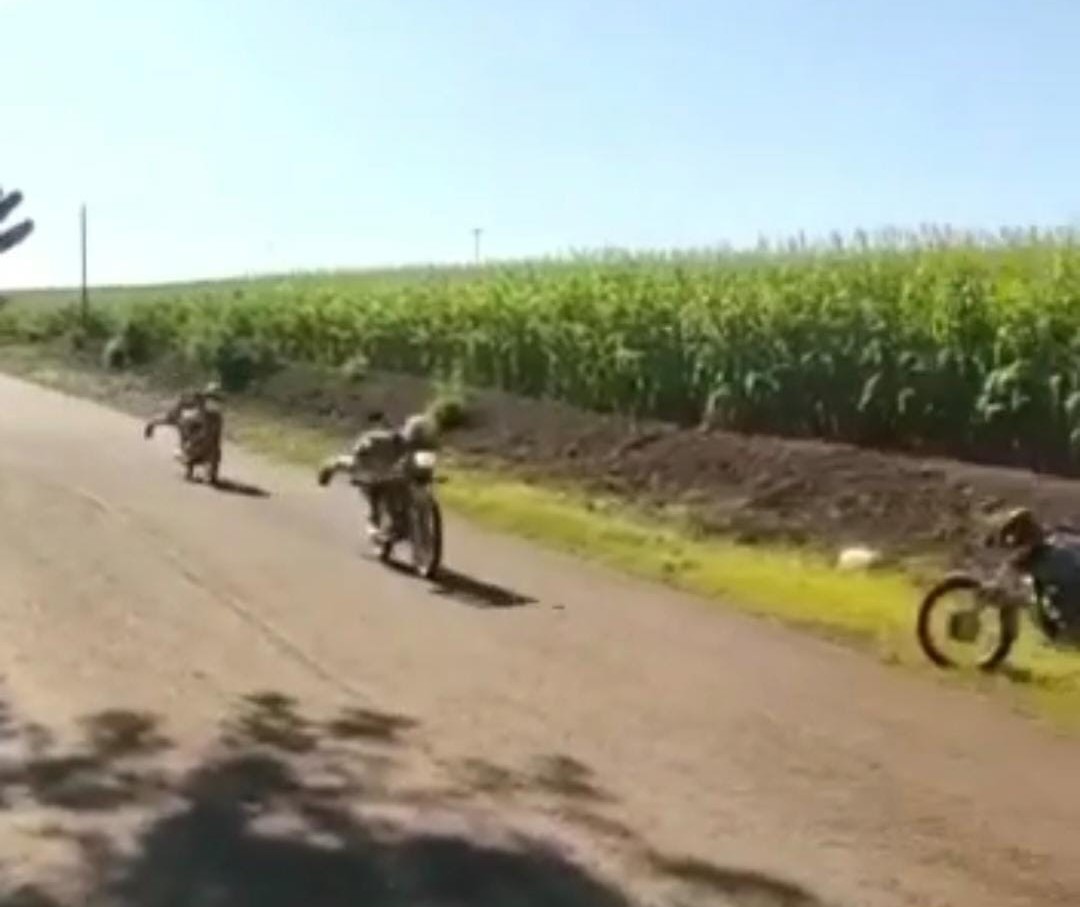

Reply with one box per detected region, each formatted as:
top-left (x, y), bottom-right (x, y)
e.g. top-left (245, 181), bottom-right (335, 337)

top-left (6, 231), bottom-right (1080, 469)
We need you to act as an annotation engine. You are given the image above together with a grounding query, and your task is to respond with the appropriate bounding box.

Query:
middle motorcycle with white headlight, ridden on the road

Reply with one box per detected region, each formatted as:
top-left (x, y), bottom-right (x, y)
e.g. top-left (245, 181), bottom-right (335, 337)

top-left (352, 450), bottom-right (443, 580)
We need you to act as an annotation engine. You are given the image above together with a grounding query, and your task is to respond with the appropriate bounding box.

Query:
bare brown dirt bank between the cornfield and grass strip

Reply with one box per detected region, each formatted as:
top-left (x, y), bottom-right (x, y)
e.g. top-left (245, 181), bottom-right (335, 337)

top-left (240, 360), bottom-right (1080, 559)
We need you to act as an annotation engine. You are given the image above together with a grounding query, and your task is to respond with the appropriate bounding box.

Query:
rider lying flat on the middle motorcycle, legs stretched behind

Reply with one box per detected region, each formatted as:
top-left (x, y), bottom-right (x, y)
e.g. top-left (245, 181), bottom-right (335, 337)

top-left (319, 410), bottom-right (436, 544)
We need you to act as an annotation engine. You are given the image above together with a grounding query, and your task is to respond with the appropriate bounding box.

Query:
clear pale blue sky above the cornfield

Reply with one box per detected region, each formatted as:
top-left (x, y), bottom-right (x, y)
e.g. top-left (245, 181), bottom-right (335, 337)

top-left (0, 0), bottom-right (1080, 286)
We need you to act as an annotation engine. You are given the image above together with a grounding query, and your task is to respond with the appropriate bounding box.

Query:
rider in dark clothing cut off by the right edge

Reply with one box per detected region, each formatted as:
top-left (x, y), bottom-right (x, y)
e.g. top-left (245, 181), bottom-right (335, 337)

top-left (989, 507), bottom-right (1080, 636)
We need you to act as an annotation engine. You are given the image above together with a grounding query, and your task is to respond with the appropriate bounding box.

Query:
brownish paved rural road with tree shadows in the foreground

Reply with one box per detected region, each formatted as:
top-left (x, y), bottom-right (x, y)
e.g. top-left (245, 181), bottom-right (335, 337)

top-left (0, 378), bottom-right (1080, 907)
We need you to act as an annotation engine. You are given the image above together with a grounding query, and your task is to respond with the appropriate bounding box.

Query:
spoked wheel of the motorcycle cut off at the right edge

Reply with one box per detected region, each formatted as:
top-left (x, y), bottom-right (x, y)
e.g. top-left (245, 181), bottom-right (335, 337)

top-left (918, 573), bottom-right (1020, 672)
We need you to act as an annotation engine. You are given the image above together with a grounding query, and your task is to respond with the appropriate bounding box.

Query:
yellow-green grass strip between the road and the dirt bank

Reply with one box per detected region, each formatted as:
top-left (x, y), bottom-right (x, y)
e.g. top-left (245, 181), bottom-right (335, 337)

top-left (6, 348), bottom-right (1080, 731)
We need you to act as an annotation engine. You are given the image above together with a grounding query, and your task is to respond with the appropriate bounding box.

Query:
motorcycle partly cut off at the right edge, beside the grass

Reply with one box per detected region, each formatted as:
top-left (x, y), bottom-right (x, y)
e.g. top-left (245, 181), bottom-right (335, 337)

top-left (916, 527), bottom-right (1080, 673)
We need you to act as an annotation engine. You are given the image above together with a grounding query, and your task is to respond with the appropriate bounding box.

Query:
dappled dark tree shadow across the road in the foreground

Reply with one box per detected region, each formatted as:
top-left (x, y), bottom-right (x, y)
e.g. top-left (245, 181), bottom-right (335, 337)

top-left (0, 692), bottom-right (820, 907)
